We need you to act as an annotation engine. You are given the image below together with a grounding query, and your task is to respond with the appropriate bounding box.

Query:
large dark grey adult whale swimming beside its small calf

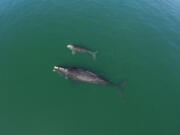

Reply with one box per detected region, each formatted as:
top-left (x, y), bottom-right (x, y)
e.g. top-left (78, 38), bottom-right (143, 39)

top-left (53, 66), bottom-right (125, 96)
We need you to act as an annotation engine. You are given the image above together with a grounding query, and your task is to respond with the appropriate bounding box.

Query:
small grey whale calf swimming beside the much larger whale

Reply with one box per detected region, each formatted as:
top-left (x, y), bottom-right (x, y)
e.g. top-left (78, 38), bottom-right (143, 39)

top-left (67, 45), bottom-right (97, 59)
